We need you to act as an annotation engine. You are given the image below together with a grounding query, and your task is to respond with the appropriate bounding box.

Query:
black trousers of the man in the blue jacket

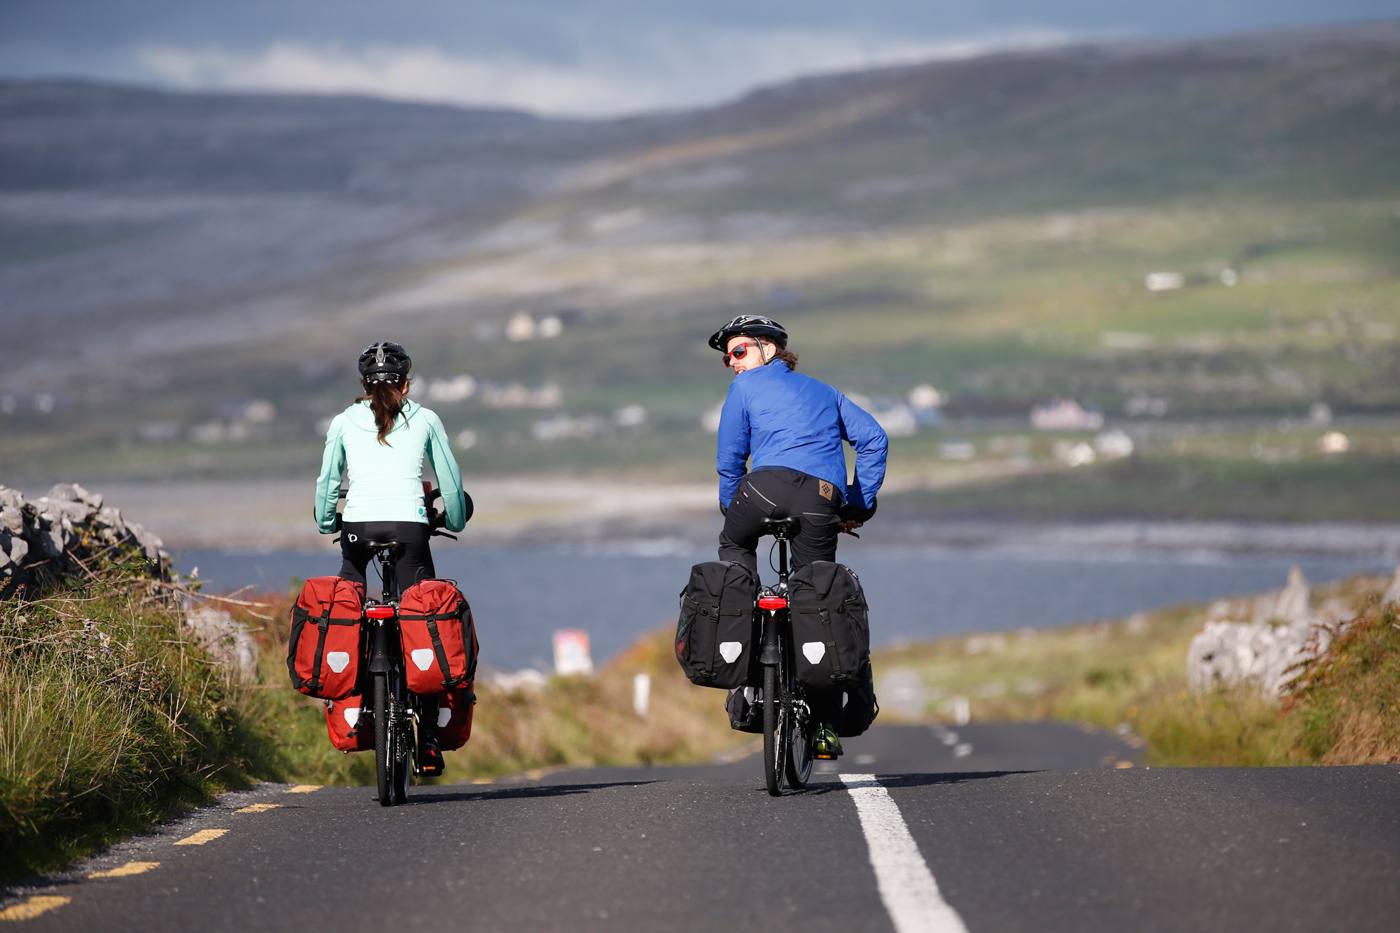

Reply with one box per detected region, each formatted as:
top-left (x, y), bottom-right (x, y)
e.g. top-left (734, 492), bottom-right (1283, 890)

top-left (720, 468), bottom-right (841, 574)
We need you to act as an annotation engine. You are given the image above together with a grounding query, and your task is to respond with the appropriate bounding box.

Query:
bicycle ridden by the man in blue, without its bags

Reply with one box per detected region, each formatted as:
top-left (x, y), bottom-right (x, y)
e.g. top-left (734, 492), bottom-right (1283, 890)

top-left (755, 518), bottom-right (816, 797)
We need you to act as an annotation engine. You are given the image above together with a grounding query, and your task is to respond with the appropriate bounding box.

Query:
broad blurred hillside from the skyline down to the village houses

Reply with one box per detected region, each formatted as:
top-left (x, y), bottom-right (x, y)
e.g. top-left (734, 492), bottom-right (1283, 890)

top-left (0, 24), bottom-right (1400, 490)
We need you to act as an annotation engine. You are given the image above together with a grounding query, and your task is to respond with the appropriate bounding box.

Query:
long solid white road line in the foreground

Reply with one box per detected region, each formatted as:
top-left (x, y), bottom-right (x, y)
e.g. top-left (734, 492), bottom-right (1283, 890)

top-left (841, 775), bottom-right (967, 933)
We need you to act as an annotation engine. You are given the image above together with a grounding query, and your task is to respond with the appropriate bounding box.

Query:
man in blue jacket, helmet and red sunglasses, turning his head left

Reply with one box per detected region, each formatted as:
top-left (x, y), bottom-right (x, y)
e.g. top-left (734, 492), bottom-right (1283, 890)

top-left (710, 315), bottom-right (889, 754)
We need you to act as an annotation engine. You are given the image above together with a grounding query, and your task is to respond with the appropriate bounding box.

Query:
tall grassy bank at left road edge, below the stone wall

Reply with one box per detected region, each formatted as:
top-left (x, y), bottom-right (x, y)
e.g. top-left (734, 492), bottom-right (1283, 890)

top-left (0, 554), bottom-right (284, 878)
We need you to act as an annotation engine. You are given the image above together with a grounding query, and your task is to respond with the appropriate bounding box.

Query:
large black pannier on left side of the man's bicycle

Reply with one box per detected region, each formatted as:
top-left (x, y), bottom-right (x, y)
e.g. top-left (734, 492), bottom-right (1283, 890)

top-left (676, 560), bottom-right (759, 689)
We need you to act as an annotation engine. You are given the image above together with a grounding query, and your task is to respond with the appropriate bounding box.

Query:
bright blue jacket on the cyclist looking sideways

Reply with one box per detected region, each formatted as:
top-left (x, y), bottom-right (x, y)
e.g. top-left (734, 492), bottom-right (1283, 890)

top-left (715, 361), bottom-right (889, 509)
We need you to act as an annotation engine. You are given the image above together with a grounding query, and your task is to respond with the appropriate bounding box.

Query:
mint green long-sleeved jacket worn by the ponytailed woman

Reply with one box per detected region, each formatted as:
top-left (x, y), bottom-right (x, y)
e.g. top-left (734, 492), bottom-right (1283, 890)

top-left (315, 399), bottom-right (466, 535)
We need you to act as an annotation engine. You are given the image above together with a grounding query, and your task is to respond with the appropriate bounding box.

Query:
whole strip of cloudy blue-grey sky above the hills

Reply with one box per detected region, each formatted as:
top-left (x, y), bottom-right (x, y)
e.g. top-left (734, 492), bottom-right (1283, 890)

top-left (8, 0), bottom-right (1400, 115)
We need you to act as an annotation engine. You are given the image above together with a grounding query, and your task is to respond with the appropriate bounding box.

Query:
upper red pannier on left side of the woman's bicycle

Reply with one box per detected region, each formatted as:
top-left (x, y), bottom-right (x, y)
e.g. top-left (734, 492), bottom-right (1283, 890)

top-left (287, 577), bottom-right (364, 699)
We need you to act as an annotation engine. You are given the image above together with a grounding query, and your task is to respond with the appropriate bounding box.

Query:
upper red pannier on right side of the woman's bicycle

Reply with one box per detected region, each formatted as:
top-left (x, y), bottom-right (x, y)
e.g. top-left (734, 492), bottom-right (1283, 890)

top-left (399, 580), bottom-right (479, 693)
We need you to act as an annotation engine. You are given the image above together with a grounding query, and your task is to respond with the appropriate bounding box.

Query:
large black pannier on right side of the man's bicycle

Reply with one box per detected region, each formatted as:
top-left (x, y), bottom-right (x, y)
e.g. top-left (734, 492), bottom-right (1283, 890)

top-left (788, 560), bottom-right (871, 689)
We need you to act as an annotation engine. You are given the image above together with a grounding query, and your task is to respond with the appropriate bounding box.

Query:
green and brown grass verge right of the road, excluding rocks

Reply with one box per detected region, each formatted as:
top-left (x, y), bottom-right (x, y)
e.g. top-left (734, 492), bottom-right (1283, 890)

top-left (875, 580), bottom-right (1400, 766)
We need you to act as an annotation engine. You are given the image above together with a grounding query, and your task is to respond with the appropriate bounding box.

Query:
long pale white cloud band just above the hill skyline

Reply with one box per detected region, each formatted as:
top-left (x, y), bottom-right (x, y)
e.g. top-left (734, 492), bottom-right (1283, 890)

top-left (136, 29), bottom-right (1070, 116)
